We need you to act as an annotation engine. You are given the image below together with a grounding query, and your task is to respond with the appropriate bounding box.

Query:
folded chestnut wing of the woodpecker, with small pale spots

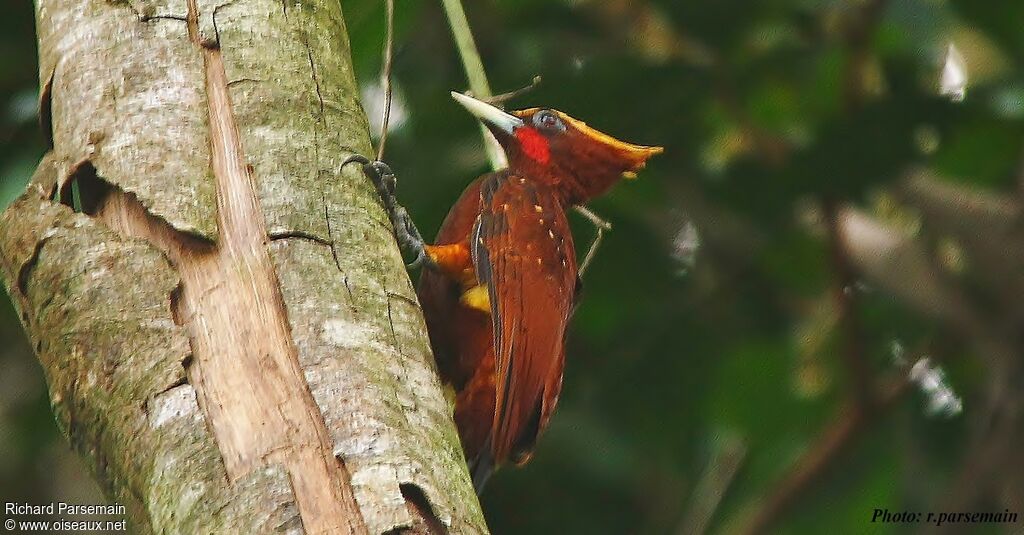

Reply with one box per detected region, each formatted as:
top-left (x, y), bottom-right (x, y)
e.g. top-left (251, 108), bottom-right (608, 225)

top-left (470, 172), bottom-right (577, 463)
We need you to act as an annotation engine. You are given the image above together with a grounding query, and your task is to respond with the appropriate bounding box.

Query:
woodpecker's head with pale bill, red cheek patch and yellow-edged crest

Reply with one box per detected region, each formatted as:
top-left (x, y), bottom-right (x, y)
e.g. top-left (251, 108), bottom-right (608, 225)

top-left (452, 91), bottom-right (663, 204)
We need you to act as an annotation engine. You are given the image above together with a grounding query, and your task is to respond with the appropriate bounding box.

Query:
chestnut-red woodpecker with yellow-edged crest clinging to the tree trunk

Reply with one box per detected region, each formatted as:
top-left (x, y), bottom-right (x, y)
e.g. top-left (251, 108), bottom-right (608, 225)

top-left (418, 92), bottom-right (662, 492)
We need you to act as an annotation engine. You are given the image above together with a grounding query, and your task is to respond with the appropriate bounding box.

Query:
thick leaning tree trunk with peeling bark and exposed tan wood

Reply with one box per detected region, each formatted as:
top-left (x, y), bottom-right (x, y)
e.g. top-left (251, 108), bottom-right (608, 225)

top-left (0, 0), bottom-right (486, 533)
